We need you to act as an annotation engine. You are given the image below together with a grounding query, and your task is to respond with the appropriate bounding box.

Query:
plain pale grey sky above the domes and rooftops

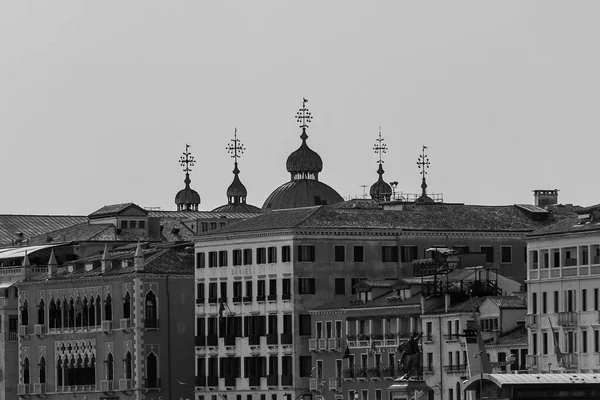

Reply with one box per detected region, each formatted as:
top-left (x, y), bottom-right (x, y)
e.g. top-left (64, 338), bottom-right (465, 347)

top-left (0, 0), bottom-right (600, 215)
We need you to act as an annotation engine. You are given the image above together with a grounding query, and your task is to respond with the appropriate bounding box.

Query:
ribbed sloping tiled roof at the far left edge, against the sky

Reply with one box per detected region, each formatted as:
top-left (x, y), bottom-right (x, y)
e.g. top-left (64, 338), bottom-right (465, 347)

top-left (0, 214), bottom-right (87, 245)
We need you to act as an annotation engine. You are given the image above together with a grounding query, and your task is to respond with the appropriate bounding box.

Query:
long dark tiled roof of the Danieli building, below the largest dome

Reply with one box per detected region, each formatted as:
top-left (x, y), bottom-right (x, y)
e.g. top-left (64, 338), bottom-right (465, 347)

top-left (207, 204), bottom-right (572, 234)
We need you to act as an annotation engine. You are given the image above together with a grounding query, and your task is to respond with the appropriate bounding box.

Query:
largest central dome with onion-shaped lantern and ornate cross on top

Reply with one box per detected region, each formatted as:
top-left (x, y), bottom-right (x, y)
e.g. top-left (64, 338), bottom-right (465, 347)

top-left (262, 99), bottom-right (344, 212)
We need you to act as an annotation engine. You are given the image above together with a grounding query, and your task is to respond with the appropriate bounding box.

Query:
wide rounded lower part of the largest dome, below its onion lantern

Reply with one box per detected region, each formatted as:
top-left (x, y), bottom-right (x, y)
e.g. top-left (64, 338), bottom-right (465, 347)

top-left (262, 179), bottom-right (344, 212)
